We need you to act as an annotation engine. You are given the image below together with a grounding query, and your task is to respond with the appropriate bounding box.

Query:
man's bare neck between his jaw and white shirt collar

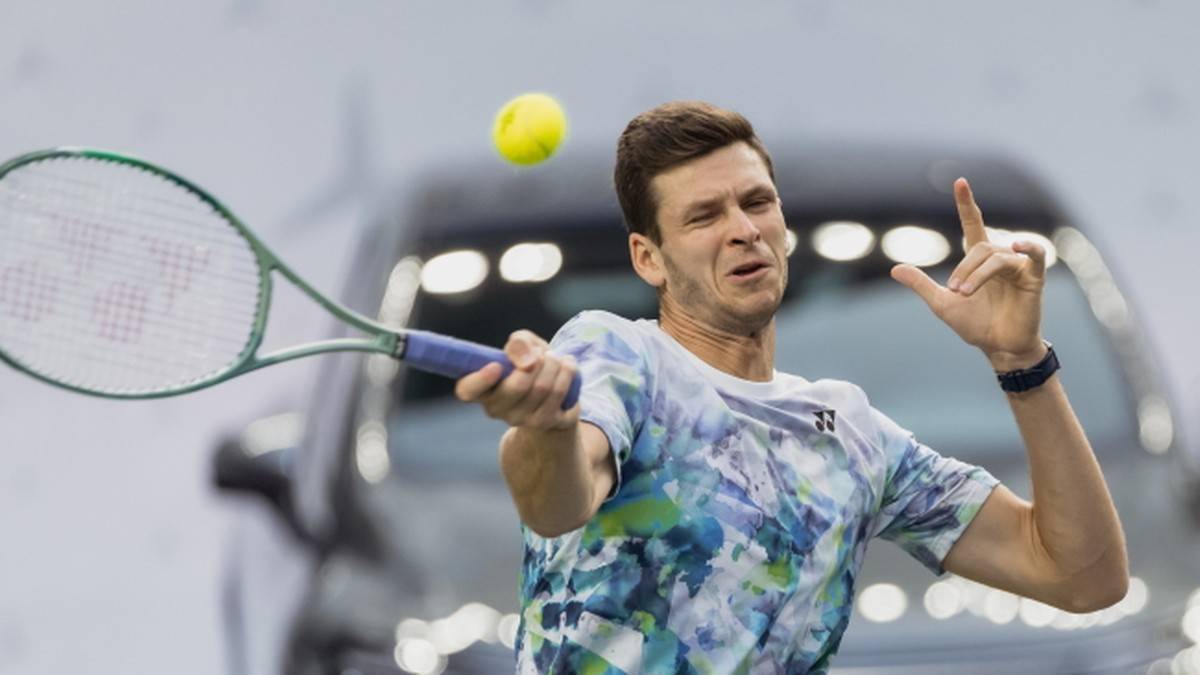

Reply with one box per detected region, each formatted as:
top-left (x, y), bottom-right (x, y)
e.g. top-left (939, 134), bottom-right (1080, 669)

top-left (659, 298), bottom-right (775, 382)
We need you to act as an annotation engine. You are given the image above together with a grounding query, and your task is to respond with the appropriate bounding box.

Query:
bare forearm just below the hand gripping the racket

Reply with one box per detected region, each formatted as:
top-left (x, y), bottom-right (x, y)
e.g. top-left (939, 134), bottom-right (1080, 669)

top-left (500, 422), bottom-right (600, 537)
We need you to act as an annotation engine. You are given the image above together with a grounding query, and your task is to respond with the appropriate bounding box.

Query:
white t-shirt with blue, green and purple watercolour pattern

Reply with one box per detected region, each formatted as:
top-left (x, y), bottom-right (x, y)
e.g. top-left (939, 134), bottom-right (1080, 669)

top-left (516, 311), bottom-right (997, 675)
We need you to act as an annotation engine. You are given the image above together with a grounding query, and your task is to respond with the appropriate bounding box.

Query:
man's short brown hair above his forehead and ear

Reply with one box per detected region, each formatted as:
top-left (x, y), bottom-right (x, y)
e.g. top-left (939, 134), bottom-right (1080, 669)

top-left (613, 101), bottom-right (775, 244)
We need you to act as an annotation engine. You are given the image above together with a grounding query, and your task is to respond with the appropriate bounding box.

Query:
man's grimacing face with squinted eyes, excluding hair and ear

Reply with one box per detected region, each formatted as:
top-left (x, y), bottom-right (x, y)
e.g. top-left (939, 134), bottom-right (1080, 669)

top-left (650, 143), bottom-right (787, 334)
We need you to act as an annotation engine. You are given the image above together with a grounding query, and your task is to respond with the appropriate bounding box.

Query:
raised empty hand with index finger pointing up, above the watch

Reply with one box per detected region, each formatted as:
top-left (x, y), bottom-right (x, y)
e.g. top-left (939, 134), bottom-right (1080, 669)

top-left (892, 178), bottom-right (1046, 371)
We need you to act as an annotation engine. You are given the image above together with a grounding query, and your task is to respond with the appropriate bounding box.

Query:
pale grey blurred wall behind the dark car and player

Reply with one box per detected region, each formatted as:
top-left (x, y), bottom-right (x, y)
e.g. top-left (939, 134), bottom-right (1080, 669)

top-left (0, 0), bottom-right (1200, 674)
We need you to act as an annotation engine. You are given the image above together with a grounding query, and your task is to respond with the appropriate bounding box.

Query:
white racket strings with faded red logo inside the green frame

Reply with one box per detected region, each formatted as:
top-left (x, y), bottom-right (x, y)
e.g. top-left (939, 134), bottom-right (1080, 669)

top-left (0, 157), bottom-right (263, 394)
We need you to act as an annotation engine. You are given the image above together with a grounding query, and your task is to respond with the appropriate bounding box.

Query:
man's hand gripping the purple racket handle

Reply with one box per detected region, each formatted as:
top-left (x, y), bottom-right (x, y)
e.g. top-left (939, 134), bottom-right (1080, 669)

top-left (455, 330), bottom-right (580, 431)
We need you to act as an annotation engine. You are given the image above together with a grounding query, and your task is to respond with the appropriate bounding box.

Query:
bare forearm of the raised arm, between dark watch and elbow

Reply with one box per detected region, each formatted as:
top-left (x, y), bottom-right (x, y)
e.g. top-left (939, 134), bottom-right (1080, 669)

top-left (1007, 376), bottom-right (1128, 587)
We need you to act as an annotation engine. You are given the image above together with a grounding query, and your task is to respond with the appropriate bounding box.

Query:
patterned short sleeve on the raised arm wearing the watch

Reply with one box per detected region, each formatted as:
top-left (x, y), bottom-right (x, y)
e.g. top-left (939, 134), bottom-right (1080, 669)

top-left (871, 407), bottom-right (1000, 575)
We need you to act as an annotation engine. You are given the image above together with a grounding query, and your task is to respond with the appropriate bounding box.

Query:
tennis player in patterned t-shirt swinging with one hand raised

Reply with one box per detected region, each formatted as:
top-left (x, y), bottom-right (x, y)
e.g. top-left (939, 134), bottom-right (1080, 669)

top-left (457, 102), bottom-right (1128, 674)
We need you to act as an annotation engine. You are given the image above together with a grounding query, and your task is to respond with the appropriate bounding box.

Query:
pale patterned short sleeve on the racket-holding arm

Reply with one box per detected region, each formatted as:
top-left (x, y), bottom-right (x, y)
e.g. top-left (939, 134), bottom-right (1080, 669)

top-left (551, 311), bottom-right (649, 498)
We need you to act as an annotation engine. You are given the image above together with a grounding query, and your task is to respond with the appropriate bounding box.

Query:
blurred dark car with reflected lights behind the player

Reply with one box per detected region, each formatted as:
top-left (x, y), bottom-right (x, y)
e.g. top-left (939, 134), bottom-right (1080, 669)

top-left (216, 144), bottom-right (1200, 674)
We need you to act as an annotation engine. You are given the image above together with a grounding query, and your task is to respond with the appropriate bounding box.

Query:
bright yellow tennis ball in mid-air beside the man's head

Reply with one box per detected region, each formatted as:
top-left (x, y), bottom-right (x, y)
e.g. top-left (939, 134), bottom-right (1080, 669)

top-left (492, 94), bottom-right (566, 166)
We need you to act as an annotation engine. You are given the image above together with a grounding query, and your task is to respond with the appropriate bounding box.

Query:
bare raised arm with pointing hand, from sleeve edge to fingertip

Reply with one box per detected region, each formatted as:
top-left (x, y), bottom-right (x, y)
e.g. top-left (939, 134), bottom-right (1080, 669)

top-left (892, 179), bottom-right (1129, 611)
